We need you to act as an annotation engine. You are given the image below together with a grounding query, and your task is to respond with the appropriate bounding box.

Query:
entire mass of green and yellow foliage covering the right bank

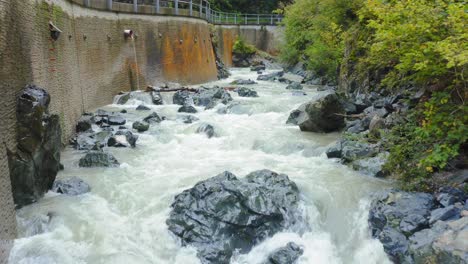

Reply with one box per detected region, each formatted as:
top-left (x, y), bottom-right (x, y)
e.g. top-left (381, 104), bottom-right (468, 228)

top-left (282, 0), bottom-right (468, 189)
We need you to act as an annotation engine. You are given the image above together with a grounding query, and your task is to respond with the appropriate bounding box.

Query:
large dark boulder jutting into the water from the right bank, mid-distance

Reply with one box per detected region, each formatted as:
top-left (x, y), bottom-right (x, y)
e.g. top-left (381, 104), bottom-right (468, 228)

top-left (288, 93), bottom-right (344, 133)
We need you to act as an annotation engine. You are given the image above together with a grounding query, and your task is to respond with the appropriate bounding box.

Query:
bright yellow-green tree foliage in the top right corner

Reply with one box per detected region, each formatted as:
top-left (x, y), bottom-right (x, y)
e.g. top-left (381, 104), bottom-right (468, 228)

top-left (359, 0), bottom-right (468, 87)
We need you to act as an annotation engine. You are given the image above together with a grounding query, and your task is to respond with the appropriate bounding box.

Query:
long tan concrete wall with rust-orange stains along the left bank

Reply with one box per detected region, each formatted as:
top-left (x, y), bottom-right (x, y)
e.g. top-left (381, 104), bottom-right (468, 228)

top-left (0, 0), bottom-right (217, 263)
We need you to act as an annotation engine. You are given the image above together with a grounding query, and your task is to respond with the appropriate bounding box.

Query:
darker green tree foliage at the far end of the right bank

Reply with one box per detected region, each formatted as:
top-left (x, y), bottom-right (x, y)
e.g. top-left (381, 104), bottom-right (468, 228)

top-left (281, 0), bottom-right (361, 79)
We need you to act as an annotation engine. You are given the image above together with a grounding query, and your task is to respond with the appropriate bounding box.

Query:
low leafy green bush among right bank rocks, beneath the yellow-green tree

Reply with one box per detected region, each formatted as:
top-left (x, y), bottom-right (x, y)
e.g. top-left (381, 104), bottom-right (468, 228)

top-left (386, 92), bottom-right (468, 191)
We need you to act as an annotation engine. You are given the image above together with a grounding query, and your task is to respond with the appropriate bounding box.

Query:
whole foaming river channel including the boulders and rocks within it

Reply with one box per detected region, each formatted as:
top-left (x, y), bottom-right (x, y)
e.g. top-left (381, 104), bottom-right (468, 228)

top-left (10, 69), bottom-right (424, 264)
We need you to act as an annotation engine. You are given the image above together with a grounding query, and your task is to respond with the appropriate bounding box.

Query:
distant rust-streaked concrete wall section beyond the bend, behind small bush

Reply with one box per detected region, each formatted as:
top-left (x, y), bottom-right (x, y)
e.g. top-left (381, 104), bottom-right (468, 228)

top-left (215, 25), bottom-right (284, 67)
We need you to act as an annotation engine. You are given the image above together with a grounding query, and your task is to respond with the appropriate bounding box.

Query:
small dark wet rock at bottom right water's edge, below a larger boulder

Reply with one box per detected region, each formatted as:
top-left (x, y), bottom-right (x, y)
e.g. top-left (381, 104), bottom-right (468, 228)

top-left (378, 226), bottom-right (409, 263)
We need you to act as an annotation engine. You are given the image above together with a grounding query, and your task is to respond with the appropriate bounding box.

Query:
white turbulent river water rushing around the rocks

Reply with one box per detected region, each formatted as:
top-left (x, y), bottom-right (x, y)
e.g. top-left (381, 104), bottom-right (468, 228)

top-left (10, 69), bottom-right (389, 264)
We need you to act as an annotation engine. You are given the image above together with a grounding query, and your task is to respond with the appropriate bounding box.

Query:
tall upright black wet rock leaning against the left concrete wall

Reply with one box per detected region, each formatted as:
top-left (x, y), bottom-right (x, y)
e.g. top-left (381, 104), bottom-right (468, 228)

top-left (7, 85), bottom-right (62, 207)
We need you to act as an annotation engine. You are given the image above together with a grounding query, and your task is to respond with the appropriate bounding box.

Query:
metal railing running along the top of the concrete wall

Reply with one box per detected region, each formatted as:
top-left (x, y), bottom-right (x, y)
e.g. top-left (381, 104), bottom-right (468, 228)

top-left (70, 0), bottom-right (283, 25)
